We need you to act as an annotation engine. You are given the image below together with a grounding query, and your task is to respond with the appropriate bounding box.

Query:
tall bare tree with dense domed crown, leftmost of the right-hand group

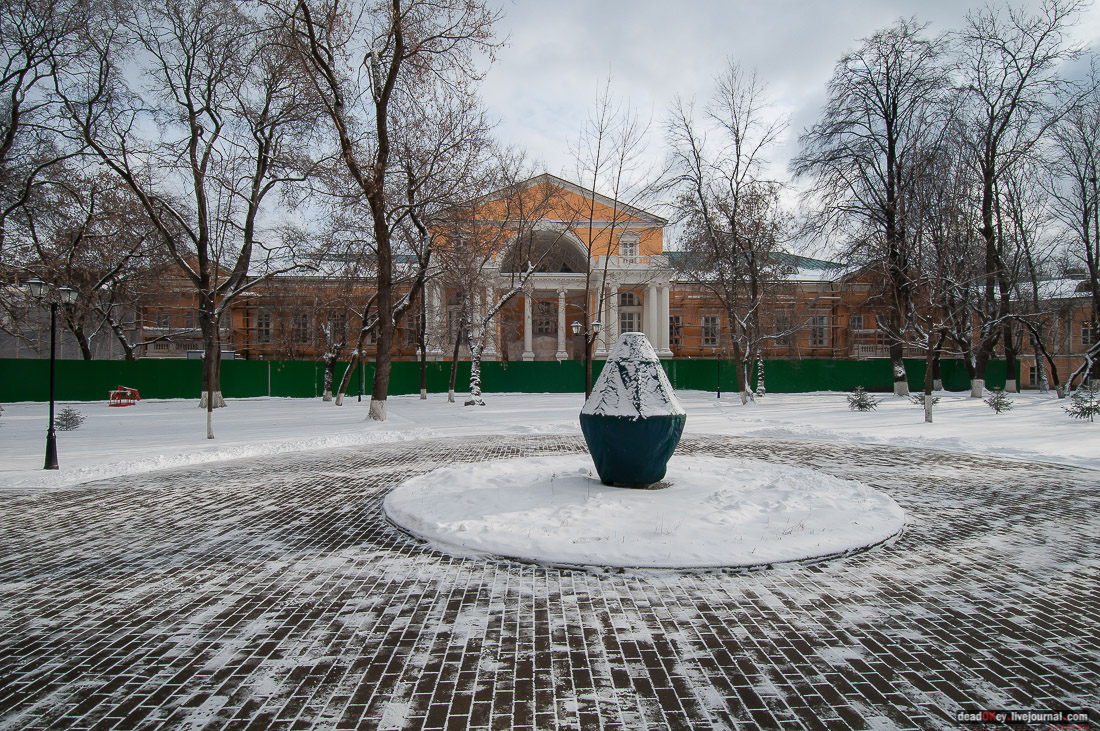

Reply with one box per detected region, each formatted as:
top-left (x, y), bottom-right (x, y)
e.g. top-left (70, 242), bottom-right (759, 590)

top-left (792, 19), bottom-right (947, 396)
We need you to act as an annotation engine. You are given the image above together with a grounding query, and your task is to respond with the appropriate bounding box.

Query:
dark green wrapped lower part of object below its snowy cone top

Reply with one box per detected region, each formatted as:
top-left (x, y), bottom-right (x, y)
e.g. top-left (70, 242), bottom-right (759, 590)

top-left (581, 413), bottom-right (688, 487)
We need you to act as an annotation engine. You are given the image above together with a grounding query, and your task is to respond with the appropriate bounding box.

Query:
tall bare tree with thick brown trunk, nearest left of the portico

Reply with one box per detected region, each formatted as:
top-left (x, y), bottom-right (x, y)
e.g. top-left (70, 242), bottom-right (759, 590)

top-left (292, 0), bottom-right (495, 421)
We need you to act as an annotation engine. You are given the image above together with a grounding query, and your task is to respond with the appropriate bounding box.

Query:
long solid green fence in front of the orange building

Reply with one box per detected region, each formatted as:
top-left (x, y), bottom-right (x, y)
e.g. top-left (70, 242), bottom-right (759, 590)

top-left (0, 358), bottom-right (1019, 403)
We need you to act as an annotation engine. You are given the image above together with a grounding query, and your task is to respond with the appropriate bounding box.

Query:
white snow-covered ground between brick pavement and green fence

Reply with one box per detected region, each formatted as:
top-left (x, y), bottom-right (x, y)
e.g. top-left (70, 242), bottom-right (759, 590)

top-left (0, 391), bottom-right (1100, 489)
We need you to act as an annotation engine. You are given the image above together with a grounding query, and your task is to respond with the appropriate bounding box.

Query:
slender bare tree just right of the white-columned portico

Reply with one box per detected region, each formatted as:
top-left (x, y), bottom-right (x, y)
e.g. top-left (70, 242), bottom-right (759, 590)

top-left (668, 63), bottom-right (789, 403)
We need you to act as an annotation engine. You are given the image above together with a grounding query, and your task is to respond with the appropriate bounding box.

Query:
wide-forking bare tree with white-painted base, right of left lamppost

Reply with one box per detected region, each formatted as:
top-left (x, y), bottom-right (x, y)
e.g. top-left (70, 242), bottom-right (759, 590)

top-left (66, 0), bottom-right (316, 439)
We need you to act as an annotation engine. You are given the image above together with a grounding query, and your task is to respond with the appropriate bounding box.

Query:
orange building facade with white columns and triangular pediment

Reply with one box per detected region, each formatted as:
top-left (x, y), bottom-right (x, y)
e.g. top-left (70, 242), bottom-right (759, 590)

top-left (0, 175), bottom-right (1100, 386)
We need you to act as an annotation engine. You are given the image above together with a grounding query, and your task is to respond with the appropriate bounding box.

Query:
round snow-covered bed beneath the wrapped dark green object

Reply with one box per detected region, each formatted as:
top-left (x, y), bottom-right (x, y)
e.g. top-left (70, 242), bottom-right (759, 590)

top-left (383, 454), bottom-right (905, 568)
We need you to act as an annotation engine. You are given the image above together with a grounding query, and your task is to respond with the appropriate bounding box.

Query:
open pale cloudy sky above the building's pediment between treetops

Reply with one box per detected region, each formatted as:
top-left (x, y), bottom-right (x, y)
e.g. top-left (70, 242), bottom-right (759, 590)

top-left (483, 0), bottom-right (1100, 206)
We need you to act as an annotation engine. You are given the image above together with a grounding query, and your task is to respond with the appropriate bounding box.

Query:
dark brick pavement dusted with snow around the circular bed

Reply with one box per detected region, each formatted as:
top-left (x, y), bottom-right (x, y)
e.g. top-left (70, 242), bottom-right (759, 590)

top-left (0, 435), bottom-right (1100, 729)
